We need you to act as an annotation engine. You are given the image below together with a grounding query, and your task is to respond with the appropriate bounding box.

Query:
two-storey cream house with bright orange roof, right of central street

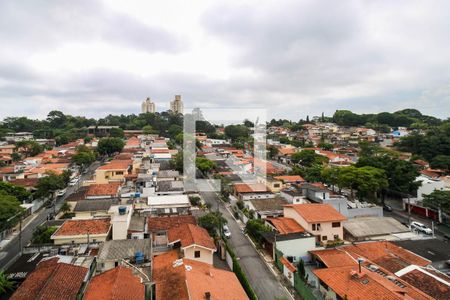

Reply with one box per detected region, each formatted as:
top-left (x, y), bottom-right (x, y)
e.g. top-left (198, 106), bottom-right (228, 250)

top-left (284, 203), bottom-right (347, 244)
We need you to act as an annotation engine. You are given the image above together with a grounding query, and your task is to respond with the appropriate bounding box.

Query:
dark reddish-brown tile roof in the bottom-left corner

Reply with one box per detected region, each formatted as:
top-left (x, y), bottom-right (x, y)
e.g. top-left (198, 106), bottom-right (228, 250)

top-left (10, 258), bottom-right (88, 300)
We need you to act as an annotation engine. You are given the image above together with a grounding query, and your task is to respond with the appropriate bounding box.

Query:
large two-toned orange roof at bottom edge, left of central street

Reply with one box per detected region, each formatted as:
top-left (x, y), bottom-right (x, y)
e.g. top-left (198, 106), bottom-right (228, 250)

top-left (153, 250), bottom-right (248, 300)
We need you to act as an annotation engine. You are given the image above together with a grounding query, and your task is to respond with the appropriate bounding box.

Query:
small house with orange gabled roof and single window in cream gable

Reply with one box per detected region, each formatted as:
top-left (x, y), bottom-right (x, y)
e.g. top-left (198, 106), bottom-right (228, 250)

top-left (167, 224), bottom-right (216, 265)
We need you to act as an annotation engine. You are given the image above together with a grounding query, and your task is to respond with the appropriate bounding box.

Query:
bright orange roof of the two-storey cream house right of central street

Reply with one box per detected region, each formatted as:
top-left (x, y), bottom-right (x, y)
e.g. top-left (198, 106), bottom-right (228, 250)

top-left (285, 203), bottom-right (347, 223)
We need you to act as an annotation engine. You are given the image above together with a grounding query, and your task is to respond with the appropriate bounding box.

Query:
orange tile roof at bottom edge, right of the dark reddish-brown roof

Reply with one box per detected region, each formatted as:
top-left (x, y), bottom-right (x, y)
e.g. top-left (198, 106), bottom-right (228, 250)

top-left (83, 266), bottom-right (145, 300)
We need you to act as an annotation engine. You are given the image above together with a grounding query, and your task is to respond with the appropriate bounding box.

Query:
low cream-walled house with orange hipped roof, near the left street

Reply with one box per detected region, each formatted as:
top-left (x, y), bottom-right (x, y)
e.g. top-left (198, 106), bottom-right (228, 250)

top-left (51, 218), bottom-right (111, 245)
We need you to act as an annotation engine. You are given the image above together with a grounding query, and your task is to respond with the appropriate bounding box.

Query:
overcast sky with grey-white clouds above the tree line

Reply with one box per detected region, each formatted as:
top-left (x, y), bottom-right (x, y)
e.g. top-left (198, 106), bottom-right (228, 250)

top-left (0, 0), bottom-right (450, 120)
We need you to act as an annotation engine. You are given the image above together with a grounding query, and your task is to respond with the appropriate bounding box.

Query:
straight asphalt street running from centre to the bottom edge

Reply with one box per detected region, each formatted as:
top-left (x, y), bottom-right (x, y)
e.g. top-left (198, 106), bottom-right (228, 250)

top-left (201, 192), bottom-right (292, 300)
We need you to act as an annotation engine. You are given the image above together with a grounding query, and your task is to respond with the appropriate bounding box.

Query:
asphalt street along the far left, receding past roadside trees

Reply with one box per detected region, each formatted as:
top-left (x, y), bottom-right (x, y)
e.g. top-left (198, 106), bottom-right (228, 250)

top-left (0, 162), bottom-right (99, 270)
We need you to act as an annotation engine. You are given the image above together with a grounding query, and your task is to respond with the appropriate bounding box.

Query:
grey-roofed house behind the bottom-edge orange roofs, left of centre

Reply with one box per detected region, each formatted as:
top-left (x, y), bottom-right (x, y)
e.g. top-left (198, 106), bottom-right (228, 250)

top-left (97, 239), bottom-right (152, 273)
